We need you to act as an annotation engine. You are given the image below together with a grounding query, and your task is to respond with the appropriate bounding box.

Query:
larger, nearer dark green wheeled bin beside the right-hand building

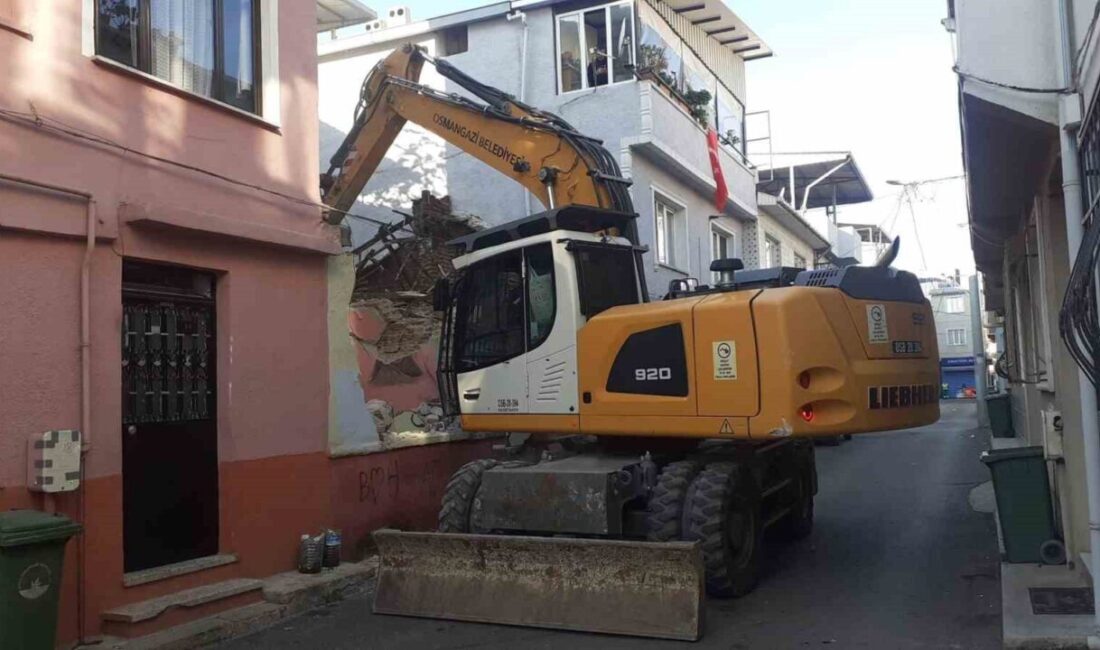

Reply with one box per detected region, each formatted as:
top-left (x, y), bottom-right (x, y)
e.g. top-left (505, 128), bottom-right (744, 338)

top-left (981, 447), bottom-right (1060, 563)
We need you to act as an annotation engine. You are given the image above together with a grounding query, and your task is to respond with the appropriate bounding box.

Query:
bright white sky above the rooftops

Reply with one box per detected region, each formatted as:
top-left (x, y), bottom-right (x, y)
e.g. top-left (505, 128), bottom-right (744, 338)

top-left (367, 0), bottom-right (974, 276)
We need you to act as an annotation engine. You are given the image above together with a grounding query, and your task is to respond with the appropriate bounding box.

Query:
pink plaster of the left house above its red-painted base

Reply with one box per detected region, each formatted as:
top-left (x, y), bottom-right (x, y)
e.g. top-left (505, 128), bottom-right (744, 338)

top-left (0, 0), bottom-right (331, 486)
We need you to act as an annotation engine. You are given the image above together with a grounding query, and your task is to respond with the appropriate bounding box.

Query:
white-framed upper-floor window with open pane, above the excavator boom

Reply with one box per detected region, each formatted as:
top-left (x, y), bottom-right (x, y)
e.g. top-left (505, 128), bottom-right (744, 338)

top-left (558, 2), bottom-right (634, 92)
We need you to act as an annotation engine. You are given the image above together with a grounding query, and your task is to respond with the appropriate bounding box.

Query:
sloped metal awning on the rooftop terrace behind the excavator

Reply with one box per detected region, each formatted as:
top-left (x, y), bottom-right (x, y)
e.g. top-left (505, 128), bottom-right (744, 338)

top-left (757, 155), bottom-right (875, 210)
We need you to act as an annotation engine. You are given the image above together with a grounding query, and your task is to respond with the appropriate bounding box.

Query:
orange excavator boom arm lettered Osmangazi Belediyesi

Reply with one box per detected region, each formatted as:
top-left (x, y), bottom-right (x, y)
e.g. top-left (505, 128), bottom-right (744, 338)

top-left (321, 45), bottom-right (634, 221)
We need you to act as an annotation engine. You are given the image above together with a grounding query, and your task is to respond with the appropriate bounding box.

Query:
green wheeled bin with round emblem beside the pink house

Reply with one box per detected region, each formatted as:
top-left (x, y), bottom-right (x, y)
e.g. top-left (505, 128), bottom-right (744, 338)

top-left (0, 510), bottom-right (80, 650)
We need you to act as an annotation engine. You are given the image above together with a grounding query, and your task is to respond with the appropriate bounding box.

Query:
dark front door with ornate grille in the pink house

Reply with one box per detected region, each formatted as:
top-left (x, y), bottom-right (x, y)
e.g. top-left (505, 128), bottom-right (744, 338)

top-left (122, 262), bottom-right (218, 572)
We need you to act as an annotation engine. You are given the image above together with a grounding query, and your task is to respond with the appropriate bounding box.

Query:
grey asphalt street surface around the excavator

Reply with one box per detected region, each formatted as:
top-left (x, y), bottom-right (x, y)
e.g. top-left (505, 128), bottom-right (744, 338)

top-left (221, 403), bottom-right (1001, 650)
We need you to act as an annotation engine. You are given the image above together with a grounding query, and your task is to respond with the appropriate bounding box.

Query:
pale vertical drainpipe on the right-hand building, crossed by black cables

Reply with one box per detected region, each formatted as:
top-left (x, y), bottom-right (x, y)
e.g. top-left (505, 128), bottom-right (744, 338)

top-left (1055, 0), bottom-right (1100, 629)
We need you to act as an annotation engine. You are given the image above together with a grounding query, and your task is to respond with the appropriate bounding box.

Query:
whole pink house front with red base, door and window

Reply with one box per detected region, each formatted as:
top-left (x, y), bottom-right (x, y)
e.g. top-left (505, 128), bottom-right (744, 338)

top-left (0, 0), bottom-right (330, 647)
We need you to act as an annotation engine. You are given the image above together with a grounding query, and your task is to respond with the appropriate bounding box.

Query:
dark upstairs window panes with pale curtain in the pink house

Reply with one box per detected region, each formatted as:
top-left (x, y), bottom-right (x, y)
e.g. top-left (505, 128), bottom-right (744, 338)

top-left (96, 0), bottom-right (260, 113)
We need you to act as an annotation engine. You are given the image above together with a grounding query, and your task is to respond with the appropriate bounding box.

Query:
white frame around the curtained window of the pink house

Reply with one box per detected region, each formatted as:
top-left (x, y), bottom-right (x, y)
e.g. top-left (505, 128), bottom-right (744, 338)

top-left (80, 0), bottom-right (283, 129)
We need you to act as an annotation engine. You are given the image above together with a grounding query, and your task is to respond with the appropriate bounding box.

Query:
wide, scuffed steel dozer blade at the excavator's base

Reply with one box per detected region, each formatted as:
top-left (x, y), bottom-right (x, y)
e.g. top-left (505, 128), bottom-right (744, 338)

top-left (374, 530), bottom-right (704, 641)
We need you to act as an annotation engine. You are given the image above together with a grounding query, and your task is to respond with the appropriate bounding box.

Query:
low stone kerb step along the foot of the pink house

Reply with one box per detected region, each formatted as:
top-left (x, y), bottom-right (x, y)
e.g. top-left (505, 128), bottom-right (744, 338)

top-left (88, 558), bottom-right (378, 650)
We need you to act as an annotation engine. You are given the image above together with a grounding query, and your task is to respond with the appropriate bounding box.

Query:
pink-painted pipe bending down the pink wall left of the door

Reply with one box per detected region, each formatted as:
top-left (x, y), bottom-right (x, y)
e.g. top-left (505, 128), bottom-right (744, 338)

top-left (0, 174), bottom-right (96, 643)
